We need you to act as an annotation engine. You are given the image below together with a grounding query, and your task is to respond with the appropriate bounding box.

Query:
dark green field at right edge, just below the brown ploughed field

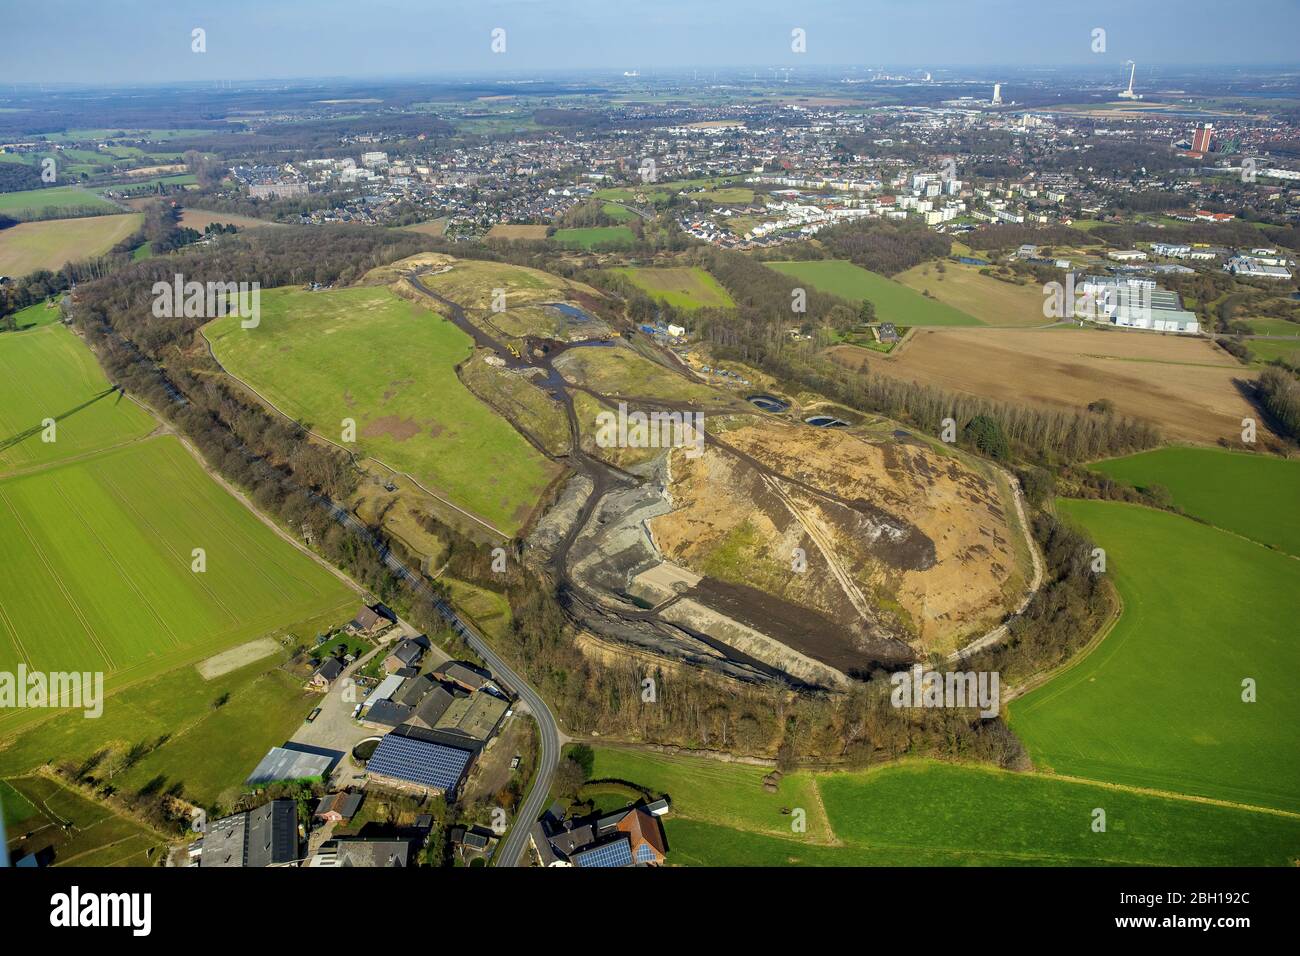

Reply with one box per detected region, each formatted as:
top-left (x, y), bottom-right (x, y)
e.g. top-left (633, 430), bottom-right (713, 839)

top-left (1092, 447), bottom-right (1300, 557)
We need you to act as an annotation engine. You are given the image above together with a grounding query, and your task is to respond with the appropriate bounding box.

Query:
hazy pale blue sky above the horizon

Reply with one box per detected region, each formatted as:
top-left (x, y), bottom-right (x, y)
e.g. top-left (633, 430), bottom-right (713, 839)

top-left (0, 0), bottom-right (1300, 85)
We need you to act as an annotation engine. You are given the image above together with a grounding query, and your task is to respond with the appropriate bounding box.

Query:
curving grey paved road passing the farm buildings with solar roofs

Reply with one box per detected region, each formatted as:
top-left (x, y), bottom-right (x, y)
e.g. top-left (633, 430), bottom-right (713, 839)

top-left (319, 498), bottom-right (560, 866)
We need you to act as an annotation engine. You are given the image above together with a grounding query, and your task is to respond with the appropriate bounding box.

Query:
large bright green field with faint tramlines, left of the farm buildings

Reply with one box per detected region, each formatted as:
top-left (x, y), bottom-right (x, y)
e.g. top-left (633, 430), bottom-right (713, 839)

top-left (0, 436), bottom-right (352, 734)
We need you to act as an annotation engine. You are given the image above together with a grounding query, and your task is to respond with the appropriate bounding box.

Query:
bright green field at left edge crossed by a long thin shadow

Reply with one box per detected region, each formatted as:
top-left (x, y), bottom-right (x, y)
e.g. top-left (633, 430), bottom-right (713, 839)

top-left (0, 323), bottom-right (155, 476)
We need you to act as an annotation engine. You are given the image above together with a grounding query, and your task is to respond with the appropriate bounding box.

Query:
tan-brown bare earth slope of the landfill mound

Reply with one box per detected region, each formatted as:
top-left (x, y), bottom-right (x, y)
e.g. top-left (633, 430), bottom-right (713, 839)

top-left (649, 420), bottom-right (1024, 671)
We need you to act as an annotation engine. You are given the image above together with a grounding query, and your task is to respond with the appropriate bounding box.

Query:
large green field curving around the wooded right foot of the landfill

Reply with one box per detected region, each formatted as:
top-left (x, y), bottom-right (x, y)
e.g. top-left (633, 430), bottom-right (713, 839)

top-left (1009, 501), bottom-right (1300, 810)
